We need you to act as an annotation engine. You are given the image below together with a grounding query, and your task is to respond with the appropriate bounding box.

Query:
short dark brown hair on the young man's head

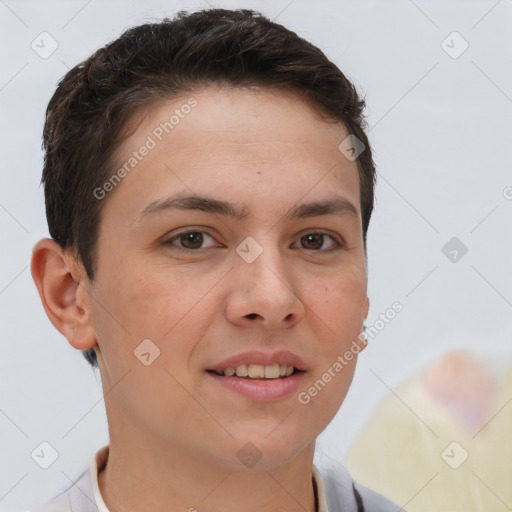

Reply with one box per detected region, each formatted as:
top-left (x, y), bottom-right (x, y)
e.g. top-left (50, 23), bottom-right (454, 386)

top-left (42, 9), bottom-right (376, 366)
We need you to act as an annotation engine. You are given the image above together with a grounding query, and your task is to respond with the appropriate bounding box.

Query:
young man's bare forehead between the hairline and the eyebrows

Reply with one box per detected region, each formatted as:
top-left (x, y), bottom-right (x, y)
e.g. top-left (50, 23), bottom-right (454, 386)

top-left (104, 87), bottom-right (359, 223)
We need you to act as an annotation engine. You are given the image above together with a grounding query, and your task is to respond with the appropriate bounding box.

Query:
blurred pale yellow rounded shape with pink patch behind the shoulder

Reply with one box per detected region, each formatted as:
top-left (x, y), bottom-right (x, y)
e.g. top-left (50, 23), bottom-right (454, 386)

top-left (346, 351), bottom-right (512, 512)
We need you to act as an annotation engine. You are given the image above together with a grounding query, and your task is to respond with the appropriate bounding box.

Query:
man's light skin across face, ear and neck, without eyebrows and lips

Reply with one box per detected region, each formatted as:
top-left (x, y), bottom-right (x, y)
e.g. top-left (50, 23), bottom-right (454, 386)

top-left (32, 87), bottom-right (369, 512)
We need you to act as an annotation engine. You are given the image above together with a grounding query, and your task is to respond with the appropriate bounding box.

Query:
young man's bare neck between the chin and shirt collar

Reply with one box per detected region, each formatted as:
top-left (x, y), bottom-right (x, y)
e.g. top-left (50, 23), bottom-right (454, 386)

top-left (98, 430), bottom-right (316, 512)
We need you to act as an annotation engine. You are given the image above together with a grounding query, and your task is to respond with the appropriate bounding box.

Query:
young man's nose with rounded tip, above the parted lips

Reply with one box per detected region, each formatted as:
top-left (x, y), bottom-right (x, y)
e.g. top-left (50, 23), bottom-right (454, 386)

top-left (226, 242), bottom-right (305, 329)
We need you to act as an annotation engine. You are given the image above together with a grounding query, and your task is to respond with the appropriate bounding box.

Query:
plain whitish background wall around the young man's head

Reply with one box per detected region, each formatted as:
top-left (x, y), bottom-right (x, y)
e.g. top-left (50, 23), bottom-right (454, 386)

top-left (0, 0), bottom-right (512, 511)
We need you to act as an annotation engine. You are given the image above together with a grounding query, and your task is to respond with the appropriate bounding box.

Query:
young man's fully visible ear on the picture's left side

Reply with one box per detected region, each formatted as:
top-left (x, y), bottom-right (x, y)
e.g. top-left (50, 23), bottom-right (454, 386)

top-left (30, 238), bottom-right (96, 350)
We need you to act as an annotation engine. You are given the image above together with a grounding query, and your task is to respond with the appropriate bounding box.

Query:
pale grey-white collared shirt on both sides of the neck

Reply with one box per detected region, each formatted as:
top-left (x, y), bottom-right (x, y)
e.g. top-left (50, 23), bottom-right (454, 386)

top-left (28, 445), bottom-right (404, 512)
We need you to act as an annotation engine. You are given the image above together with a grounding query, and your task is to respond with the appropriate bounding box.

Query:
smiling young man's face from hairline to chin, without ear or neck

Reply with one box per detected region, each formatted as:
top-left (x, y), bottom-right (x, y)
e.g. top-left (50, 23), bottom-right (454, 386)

top-left (88, 88), bottom-right (368, 467)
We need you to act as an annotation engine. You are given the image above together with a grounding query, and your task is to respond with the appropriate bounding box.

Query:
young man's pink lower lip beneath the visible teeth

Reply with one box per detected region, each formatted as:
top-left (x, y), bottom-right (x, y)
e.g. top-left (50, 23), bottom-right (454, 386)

top-left (206, 372), bottom-right (306, 402)
